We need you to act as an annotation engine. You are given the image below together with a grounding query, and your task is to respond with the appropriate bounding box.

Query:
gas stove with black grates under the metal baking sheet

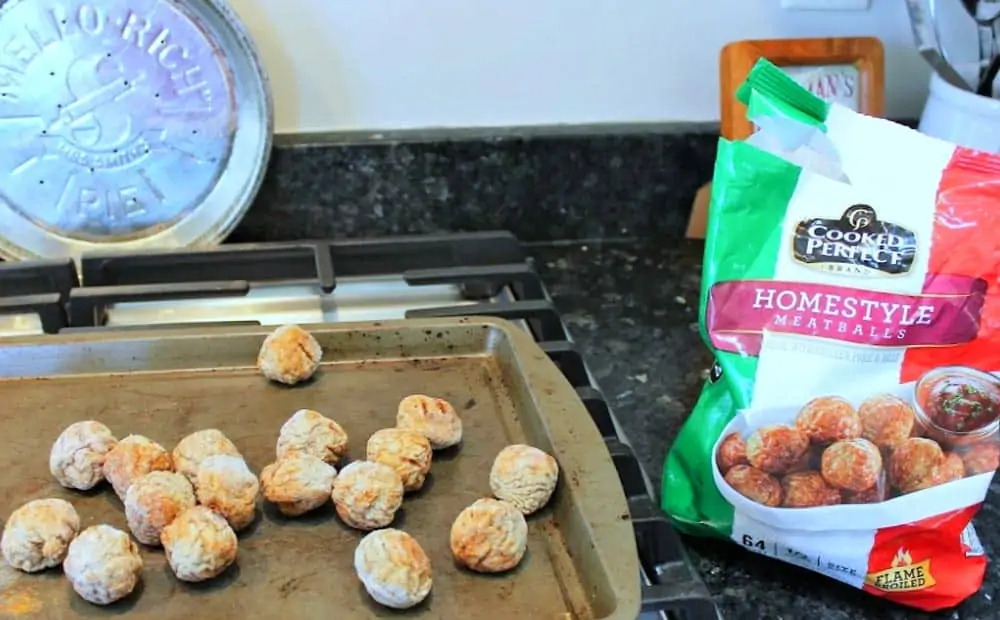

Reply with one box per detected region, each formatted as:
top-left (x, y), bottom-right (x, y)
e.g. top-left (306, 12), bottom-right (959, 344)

top-left (0, 232), bottom-right (717, 620)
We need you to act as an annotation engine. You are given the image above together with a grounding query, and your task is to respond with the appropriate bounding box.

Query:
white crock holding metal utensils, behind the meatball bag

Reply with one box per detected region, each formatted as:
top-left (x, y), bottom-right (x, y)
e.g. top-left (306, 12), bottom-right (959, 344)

top-left (919, 68), bottom-right (1000, 153)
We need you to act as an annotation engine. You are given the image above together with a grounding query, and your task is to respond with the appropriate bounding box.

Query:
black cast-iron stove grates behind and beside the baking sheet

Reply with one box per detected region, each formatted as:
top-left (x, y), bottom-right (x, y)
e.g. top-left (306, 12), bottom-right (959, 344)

top-left (0, 232), bottom-right (718, 620)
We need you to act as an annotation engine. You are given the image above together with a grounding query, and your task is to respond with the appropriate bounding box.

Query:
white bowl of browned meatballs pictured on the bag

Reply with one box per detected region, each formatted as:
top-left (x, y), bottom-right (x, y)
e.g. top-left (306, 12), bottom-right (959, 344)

top-left (714, 383), bottom-right (1000, 529)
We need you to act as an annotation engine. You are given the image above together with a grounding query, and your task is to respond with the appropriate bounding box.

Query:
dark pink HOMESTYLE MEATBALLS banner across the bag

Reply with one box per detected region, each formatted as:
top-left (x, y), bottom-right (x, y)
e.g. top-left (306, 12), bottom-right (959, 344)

top-left (705, 274), bottom-right (987, 355)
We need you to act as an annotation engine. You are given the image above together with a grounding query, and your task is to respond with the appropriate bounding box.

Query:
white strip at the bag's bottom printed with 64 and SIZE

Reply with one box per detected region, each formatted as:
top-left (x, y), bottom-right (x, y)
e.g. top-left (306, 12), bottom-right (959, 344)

top-left (731, 509), bottom-right (875, 588)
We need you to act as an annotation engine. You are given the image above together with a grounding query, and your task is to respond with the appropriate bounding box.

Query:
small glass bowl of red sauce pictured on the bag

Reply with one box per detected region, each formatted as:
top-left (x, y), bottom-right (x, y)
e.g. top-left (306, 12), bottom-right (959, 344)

top-left (913, 366), bottom-right (1000, 447)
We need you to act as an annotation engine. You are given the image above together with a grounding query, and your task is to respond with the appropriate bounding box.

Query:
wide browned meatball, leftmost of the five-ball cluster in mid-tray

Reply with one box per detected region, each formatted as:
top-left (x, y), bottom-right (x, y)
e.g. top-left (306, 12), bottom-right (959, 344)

top-left (260, 454), bottom-right (337, 517)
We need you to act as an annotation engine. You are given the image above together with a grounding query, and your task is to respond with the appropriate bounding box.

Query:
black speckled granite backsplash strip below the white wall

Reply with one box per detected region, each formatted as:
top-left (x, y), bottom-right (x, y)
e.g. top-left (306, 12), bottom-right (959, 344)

top-left (229, 131), bottom-right (718, 241)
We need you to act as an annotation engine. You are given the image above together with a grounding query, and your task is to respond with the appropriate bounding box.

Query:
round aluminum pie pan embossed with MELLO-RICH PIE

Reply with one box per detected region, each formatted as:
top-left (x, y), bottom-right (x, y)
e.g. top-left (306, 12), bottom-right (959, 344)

top-left (0, 0), bottom-right (274, 259)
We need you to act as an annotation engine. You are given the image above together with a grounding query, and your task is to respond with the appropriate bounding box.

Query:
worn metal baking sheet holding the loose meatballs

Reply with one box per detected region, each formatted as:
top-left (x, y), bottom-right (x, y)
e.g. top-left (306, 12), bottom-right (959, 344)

top-left (0, 318), bottom-right (640, 620)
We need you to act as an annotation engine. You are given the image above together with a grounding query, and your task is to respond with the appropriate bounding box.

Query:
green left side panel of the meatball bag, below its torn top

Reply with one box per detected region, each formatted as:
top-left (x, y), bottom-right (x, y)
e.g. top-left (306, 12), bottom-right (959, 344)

top-left (662, 140), bottom-right (801, 537)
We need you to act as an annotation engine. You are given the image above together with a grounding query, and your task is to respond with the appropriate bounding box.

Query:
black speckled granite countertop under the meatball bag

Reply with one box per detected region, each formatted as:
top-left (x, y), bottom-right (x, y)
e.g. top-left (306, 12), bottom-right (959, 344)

top-left (529, 240), bottom-right (1000, 620)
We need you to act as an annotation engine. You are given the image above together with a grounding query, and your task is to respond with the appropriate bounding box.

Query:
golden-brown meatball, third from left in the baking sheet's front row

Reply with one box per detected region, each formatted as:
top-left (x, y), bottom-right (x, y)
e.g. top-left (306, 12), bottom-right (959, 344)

top-left (162, 506), bottom-right (237, 581)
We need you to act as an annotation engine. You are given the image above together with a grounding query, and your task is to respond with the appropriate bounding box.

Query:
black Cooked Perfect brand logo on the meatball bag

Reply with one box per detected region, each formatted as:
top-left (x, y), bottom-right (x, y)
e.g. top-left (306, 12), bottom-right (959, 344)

top-left (792, 204), bottom-right (917, 277)
